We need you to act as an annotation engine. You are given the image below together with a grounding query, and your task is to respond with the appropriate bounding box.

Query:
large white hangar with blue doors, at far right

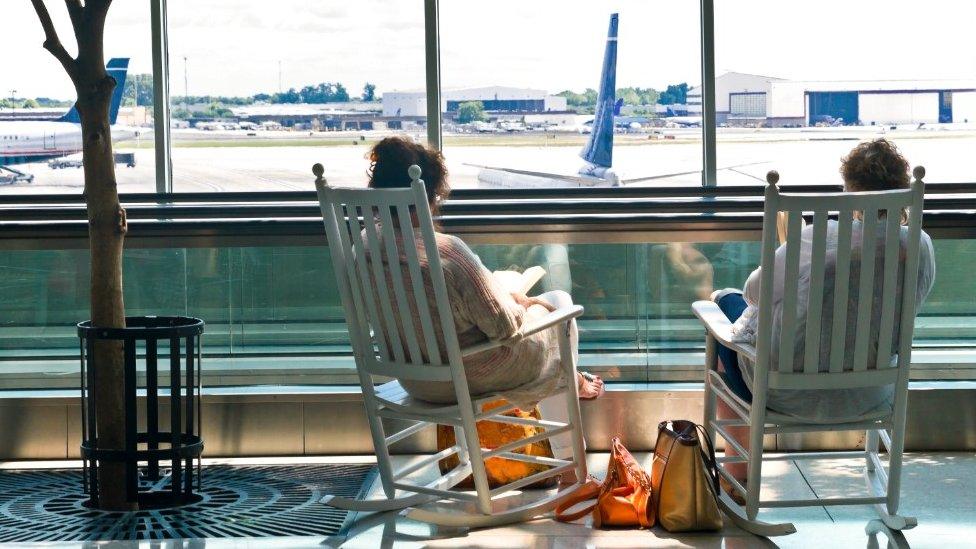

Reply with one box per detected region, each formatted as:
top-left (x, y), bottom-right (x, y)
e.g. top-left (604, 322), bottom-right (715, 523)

top-left (687, 72), bottom-right (976, 127)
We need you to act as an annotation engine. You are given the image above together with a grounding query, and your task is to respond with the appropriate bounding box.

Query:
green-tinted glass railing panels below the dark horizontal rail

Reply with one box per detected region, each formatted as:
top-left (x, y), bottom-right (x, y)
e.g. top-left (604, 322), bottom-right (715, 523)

top-left (0, 236), bottom-right (976, 388)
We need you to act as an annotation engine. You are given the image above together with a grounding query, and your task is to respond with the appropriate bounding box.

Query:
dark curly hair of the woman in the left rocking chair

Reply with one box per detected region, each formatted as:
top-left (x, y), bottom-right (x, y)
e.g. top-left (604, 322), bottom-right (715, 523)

top-left (366, 136), bottom-right (451, 214)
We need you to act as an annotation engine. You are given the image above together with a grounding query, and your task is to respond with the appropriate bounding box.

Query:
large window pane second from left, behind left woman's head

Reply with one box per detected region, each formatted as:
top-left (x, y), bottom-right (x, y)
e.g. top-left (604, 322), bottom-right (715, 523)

top-left (169, 0), bottom-right (426, 192)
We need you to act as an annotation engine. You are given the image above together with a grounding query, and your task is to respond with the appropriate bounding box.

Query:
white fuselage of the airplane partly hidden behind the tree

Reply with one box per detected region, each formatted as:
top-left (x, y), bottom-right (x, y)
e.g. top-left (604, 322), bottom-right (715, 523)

top-left (0, 121), bottom-right (138, 166)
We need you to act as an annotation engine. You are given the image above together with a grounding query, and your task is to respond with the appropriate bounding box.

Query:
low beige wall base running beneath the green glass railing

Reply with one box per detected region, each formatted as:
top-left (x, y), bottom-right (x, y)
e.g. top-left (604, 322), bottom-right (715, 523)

top-left (0, 384), bottom-right (976, 461)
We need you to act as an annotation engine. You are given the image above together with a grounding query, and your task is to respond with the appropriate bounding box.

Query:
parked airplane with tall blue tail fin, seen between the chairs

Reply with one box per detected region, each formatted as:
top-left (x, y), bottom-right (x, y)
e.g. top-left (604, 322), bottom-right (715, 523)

top-left (475, 13), bottom-right (763, 188)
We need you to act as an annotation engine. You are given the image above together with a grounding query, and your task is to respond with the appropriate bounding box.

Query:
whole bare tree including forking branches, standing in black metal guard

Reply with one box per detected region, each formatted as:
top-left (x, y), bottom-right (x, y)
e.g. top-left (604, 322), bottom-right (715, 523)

top-left (31, 0), bottom-right (132, 510)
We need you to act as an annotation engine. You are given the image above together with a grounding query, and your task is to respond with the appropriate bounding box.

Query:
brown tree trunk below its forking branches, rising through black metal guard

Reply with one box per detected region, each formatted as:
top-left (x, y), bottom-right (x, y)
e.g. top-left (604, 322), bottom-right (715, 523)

top-left (78, 68), bottom-right (135, 510)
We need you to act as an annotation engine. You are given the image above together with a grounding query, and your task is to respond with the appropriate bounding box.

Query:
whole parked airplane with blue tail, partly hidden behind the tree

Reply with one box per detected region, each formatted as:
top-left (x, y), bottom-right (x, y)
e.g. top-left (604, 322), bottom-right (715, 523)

top-left (0, 58), bottom-right (138, 182)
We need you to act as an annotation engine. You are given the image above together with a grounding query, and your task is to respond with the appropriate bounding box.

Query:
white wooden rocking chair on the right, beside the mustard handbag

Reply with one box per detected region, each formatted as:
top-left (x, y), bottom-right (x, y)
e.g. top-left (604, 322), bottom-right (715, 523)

top-left (692, 166), bottom-right (925, 536)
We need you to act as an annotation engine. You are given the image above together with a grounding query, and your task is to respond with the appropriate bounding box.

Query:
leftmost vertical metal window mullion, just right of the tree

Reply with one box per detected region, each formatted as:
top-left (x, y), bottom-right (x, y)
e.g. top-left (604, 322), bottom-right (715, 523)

top-left (150, 0), bottom-right (173, 193)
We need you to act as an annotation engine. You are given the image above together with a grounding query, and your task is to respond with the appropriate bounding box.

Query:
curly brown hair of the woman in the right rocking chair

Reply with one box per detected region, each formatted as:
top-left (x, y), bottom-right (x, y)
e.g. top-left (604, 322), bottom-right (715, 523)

top-left (840, 138), bottom-right (911, 192)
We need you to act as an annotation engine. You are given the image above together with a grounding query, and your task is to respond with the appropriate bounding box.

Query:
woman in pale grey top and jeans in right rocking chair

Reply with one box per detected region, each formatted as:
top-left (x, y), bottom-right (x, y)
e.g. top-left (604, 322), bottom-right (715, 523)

top-left (712, 139), bottom-right (935, 496)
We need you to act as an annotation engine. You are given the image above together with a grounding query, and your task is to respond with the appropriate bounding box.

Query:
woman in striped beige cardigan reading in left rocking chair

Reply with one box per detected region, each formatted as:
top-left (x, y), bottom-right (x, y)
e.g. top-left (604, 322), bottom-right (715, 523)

top-left (360, 137), bottom-right (603, 451)
